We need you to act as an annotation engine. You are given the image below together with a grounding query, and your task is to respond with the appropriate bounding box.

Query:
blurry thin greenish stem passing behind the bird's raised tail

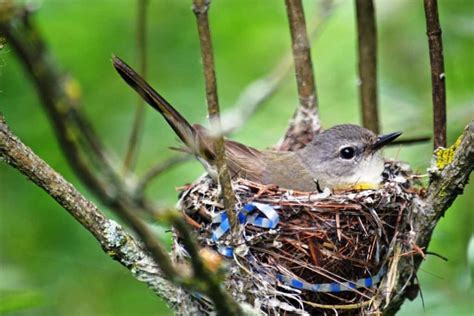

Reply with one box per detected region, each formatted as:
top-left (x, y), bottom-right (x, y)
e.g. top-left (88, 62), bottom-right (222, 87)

top-left (123, 0), bottom-right (148, 173)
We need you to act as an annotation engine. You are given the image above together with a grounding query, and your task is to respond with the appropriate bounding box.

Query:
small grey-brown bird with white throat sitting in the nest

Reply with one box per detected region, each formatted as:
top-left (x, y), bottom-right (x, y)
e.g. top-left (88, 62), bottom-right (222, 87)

top-left (112, 56), bottom-right (401, 192)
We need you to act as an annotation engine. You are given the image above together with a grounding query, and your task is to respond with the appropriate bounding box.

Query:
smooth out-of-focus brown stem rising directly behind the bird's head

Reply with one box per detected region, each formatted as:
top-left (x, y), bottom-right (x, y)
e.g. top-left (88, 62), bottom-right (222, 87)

top-left (355, 0), bottom-right (380, 134)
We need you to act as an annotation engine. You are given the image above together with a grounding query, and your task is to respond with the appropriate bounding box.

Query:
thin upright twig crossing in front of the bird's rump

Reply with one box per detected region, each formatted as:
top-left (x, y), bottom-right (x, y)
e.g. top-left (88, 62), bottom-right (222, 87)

top-left (193, 0), bottom-right (238, 236)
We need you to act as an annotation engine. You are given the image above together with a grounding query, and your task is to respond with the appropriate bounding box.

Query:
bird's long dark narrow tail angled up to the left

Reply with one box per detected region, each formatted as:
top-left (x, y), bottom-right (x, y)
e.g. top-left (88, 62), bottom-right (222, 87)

top-left (112, 56), bottom-right (213, 160)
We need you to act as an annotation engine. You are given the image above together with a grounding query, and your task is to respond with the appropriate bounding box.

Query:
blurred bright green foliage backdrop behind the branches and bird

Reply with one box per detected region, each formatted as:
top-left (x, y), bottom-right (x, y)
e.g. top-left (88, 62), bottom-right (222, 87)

top-left (0, 0), bottom-right (474, 315)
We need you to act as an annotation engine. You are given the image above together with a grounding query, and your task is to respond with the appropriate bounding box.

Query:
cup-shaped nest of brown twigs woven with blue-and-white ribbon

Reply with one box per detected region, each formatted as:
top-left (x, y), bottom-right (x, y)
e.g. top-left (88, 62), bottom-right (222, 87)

top-left (174, 162), bottom-right (421, 315)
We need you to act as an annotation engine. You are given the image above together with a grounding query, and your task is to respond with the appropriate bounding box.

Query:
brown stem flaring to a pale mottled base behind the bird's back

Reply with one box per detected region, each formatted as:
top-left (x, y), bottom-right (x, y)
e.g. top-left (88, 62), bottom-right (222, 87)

top-left (279, 0), bottom-right (321, 150)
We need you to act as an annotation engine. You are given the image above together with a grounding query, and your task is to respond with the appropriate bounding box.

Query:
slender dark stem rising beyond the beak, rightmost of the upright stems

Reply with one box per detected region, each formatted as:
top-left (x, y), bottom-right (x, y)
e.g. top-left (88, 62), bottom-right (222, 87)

top-left (424, 0), bottom-right (446, 149)
